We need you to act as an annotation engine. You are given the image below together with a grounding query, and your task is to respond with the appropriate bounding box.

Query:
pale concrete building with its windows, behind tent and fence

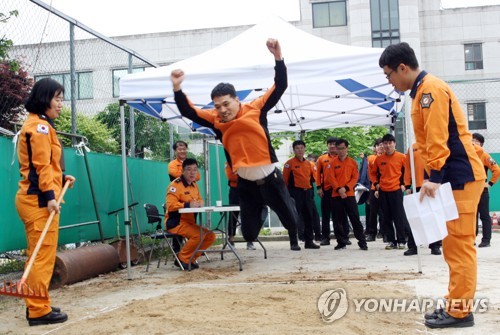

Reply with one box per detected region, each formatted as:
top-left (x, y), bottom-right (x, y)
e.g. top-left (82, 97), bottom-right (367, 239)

top-left (6, 0), bottom-right (500, 152)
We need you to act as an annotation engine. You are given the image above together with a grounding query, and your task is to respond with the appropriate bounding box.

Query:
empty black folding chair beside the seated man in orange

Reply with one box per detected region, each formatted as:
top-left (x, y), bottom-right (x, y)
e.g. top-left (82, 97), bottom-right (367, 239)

top-left (144, 204), bottom-right (184, 272)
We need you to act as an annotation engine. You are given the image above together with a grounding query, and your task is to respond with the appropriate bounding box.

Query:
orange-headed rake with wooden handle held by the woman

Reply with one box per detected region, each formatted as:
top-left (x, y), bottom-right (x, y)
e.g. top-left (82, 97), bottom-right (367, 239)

top-left (0, 180), bottom-right (70, 299)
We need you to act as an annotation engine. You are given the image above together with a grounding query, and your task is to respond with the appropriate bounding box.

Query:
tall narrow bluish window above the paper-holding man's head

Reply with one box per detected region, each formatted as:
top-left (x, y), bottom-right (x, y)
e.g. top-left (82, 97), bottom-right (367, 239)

top-left (370, 0), bottom-right (400, 48)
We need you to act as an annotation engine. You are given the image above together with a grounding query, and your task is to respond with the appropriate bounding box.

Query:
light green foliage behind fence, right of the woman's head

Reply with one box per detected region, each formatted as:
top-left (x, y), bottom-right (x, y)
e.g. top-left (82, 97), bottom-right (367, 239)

top-left (54, 108), bottom-right (120, 154)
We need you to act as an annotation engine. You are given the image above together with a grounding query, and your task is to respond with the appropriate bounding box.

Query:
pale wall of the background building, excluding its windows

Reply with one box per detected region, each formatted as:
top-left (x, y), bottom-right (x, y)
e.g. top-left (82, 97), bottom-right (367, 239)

top-left (6, 0), bottom-right (500, 152)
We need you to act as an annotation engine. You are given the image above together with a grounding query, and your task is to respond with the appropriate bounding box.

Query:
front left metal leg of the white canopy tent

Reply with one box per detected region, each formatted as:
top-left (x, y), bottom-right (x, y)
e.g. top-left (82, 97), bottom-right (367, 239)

top-left (120, 100), bottom-right (132, 280)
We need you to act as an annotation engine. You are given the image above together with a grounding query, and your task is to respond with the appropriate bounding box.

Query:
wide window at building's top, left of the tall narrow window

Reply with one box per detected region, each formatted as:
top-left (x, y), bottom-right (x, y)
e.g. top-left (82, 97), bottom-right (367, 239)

top-left (312, 0), bottom-right (347, 28)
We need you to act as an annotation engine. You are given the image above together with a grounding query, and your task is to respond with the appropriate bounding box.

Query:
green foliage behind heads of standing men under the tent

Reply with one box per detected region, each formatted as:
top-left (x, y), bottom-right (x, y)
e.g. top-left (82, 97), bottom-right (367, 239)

top-left (303, 126), bottom-right (388, 158)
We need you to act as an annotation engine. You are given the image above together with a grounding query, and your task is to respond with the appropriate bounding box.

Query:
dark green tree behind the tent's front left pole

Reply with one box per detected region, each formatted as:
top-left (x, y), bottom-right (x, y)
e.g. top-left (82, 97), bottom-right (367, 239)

top-left (97, 103), bottom-right (178, 161)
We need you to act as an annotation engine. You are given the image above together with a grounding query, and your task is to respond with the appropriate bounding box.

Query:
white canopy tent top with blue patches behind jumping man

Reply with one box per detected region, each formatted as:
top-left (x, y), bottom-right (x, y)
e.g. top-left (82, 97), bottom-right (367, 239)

top-left (120, 17), bottom-right (402, 132)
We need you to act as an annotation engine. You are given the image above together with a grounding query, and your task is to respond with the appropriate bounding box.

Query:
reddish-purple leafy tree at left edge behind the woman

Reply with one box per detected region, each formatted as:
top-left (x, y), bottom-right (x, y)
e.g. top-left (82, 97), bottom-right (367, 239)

top-left (0, 10), bottom-right (33, 129)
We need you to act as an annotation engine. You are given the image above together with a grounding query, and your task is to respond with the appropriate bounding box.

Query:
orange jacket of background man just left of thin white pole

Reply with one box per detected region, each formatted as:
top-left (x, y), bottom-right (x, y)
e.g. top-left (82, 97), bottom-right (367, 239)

top-left (370, 151), bottom-right (406, 192)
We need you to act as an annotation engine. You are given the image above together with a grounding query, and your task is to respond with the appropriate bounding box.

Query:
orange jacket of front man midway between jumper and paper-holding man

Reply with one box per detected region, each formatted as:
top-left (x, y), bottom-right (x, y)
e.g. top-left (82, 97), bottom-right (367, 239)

top-left (331, 157), bottom-right (359, 197)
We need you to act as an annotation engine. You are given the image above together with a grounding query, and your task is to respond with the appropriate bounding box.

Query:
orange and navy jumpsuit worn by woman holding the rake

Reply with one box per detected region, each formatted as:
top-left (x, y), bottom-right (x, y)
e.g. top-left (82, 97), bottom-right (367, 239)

top-left (16, 113), bottom-right (64, 318)
